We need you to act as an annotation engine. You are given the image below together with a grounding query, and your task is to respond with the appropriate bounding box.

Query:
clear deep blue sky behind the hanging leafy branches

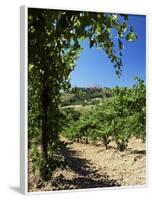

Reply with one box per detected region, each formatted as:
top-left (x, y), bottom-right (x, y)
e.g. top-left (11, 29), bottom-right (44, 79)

top-left (70, 15), bottom-right (146, 87)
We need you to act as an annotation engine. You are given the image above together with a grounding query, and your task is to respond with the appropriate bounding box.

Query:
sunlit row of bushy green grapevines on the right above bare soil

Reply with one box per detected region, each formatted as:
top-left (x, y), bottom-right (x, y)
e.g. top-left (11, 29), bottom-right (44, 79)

top-left (63, 79), bottom-right (146, 151)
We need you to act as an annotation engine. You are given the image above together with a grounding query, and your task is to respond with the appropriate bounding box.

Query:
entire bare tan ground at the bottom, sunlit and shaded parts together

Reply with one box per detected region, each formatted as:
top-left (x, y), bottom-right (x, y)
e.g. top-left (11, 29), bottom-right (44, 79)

top-left (29, 137), bottom-right (146, 192)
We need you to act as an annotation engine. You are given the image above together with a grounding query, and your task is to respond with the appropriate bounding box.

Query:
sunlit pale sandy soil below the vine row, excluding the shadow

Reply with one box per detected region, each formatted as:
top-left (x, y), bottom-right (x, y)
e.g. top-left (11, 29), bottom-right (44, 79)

top-left (63, 136), bottom-right (146, 185)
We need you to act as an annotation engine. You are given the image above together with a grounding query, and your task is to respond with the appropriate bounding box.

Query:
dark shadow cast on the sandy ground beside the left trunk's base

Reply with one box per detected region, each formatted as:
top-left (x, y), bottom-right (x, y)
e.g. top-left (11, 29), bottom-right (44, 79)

top-left (51, 141), bottom-right (120, 190)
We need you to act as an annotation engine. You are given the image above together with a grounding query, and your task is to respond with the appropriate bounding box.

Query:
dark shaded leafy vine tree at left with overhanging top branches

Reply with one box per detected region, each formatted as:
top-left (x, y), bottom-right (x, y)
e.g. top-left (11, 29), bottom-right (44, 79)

top-left (28, 8), bottom-right (136, 178)
